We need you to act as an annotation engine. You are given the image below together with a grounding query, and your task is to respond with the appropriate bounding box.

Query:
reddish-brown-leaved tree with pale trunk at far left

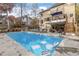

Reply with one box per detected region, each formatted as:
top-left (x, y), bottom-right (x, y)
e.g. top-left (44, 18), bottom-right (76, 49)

top-left (0, 3), bottom-right (14, 29)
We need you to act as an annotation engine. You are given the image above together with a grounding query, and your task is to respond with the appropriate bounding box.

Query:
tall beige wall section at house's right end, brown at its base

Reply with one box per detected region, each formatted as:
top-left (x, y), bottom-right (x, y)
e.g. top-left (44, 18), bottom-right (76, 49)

top-left (64, 3), bottom-right (76, 33)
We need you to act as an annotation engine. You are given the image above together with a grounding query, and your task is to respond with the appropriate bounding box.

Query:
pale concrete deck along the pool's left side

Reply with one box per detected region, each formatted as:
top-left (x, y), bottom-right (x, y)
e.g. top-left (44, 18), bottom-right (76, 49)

top-left (0, 33), bottom-right (33, 56)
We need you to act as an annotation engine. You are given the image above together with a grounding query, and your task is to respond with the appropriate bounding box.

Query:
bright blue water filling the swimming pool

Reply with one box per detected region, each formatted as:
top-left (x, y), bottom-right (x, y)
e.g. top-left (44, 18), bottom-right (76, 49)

top-left (7, 32), bottom-right (63, 56)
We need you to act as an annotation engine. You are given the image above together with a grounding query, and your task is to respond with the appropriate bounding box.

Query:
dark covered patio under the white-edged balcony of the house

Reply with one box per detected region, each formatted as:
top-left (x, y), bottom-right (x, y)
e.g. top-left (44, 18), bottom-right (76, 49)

top-left (46, 19), bottom-right (66, 33)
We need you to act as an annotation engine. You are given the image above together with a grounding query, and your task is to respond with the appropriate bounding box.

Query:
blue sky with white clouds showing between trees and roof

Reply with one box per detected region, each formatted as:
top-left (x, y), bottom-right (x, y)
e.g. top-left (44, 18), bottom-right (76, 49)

top-left (9, 3), bottom-right (54, 17)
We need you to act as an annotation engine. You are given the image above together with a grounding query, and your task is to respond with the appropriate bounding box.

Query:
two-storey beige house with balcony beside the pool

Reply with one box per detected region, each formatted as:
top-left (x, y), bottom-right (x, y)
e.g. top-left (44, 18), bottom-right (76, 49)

top-left (40, 3), bottom-right (79, 33)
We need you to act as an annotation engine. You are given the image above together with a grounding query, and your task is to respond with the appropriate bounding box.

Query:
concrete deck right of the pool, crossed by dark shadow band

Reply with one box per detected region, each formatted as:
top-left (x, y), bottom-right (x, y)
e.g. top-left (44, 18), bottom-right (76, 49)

top-left (55, 39), bottom-right (79, 56)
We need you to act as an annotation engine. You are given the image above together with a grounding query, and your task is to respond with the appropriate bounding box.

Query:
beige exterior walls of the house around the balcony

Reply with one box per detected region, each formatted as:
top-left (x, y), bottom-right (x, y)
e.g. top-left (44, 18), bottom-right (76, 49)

top-left (39, 3), bottom-right (77, 33)
